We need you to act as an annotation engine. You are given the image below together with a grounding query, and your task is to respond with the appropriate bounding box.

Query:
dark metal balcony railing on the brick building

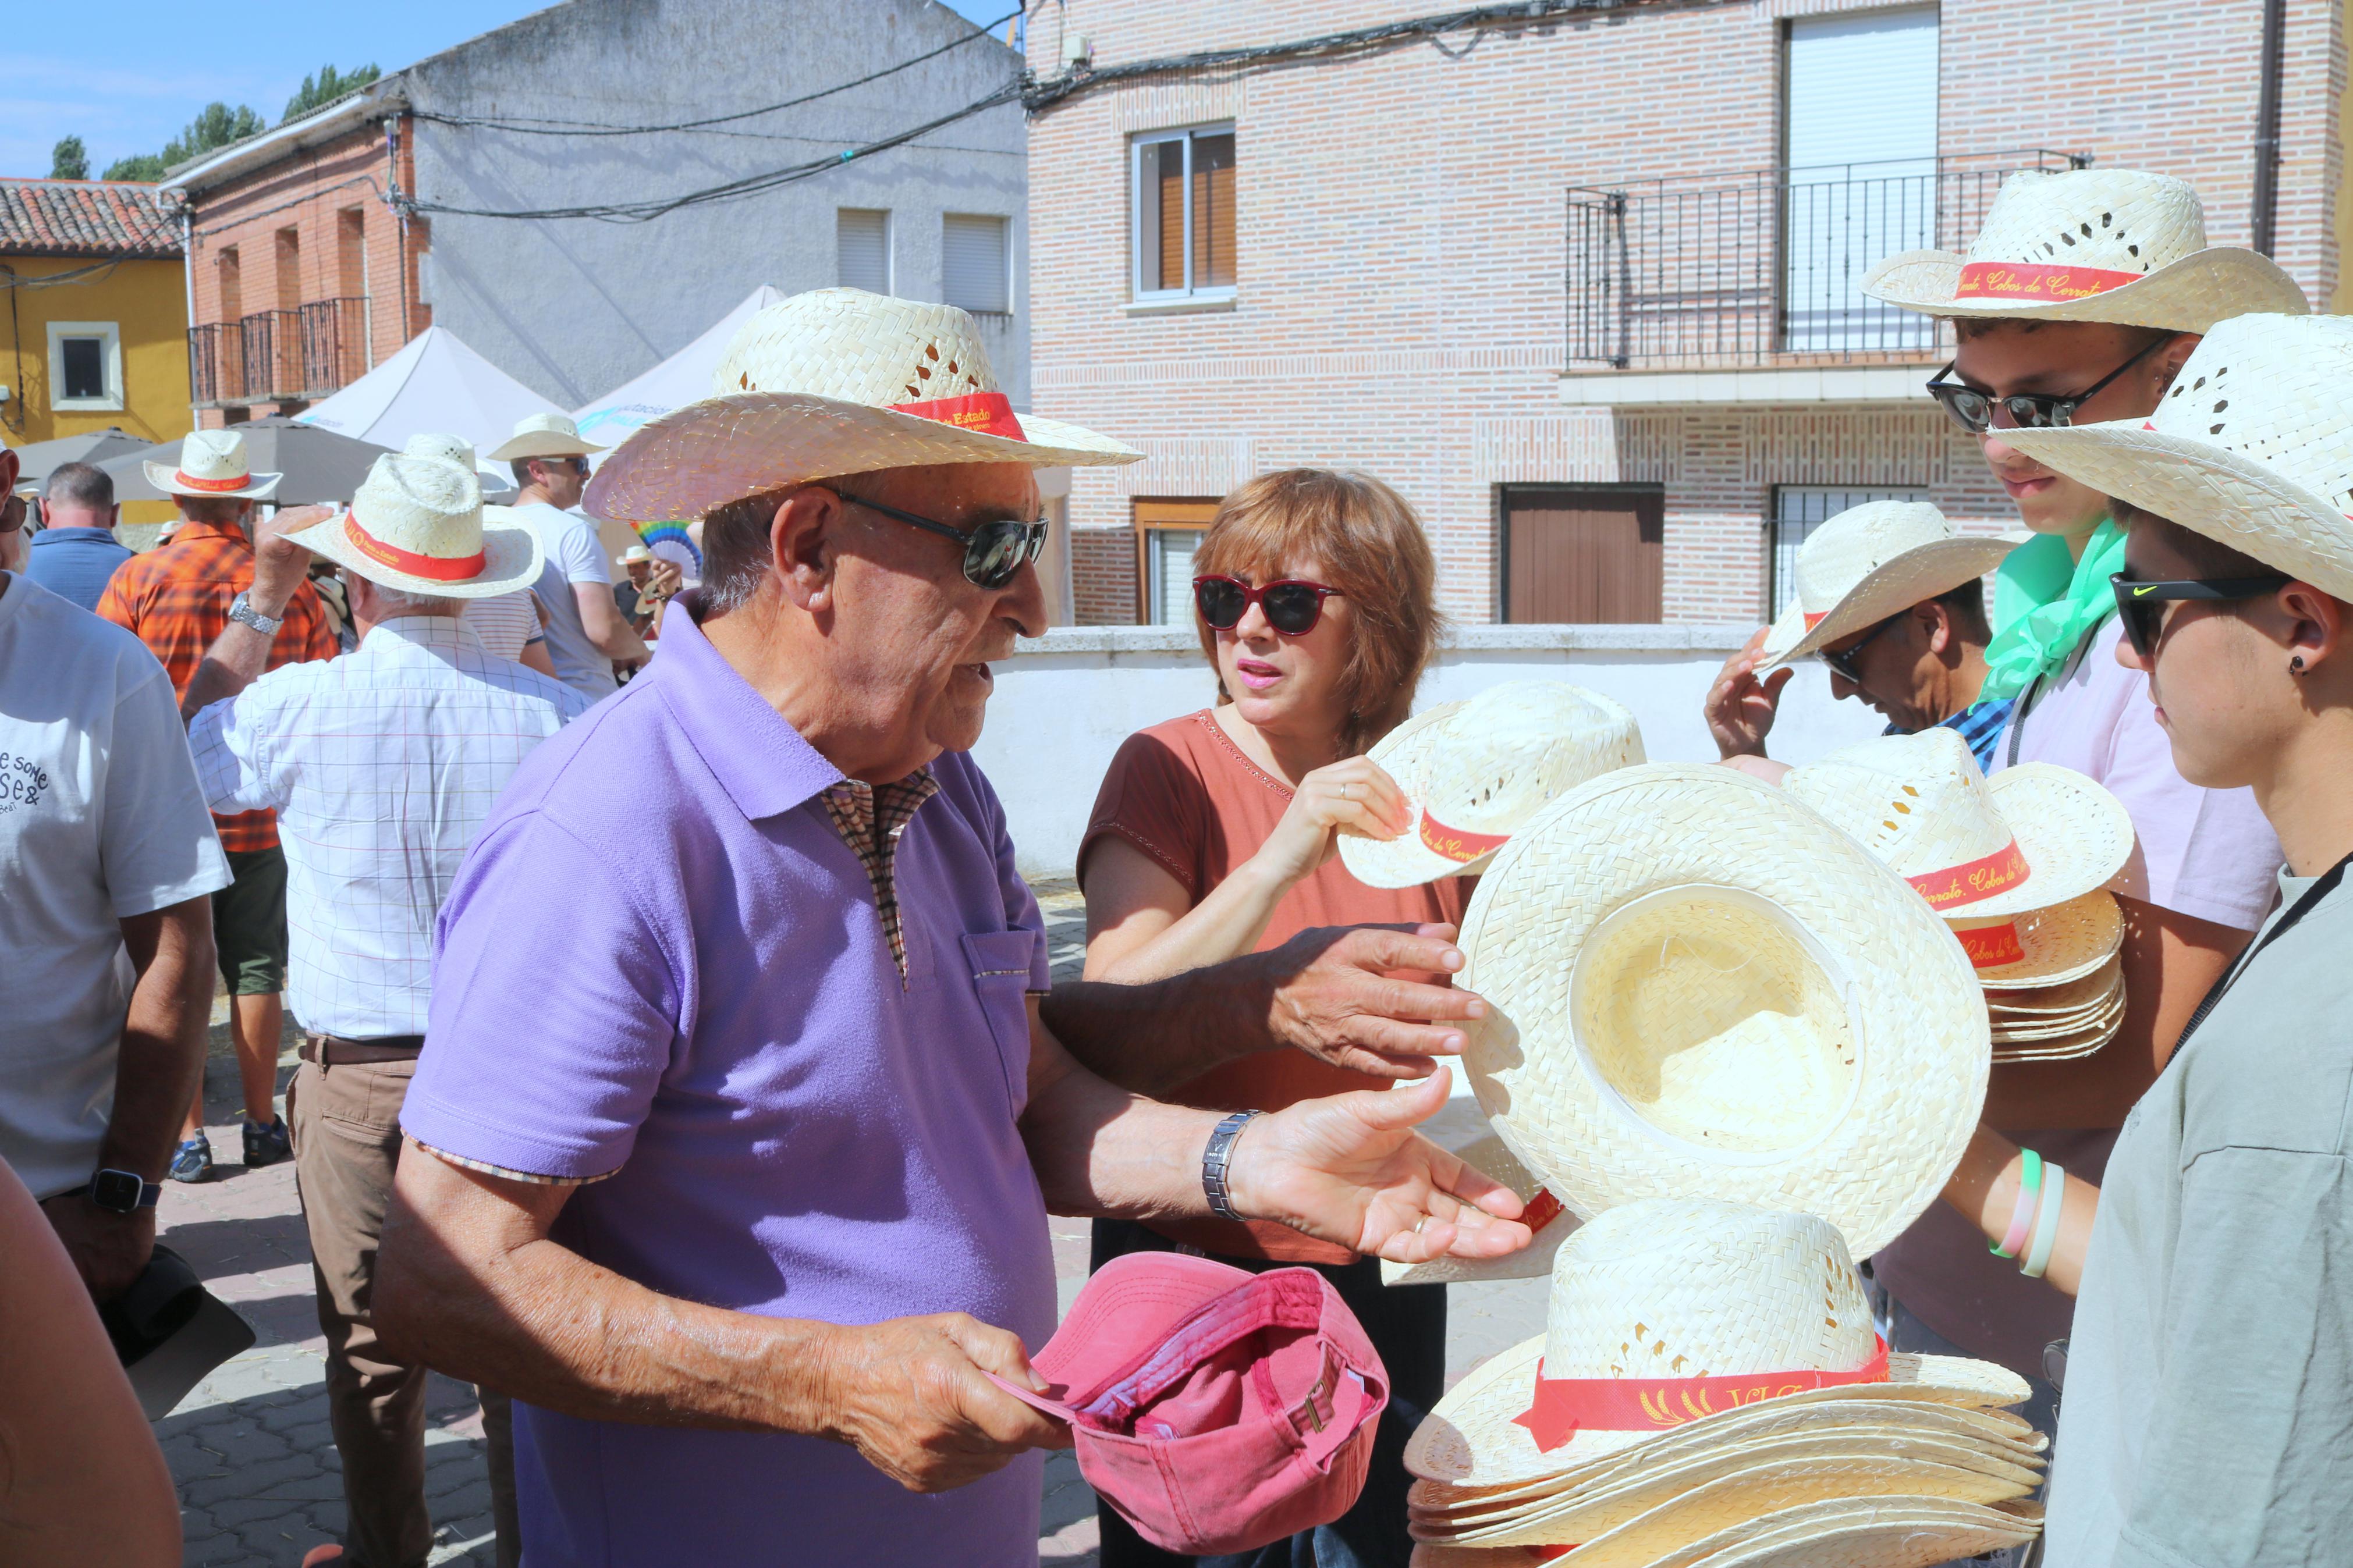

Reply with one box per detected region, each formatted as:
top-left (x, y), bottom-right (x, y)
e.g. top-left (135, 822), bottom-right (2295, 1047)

top-left (1567, 151), bottom-right (2092, 369)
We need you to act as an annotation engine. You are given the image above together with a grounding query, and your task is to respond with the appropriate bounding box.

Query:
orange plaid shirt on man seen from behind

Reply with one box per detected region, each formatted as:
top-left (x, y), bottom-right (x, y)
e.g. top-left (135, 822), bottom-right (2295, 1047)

top-left (99, 522), bottom-right (339, 851)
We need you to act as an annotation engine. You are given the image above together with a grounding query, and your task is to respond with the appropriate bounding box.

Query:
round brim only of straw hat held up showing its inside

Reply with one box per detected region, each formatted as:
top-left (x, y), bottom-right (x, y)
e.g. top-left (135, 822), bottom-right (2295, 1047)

top-left (1461, 764), bottom-right (1990, 1258)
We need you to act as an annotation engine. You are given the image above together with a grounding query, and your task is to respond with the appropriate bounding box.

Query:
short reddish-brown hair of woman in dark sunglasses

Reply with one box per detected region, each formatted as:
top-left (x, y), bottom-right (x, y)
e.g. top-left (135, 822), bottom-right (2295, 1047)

top-left (1193, 468), bottom-right (1445, 757)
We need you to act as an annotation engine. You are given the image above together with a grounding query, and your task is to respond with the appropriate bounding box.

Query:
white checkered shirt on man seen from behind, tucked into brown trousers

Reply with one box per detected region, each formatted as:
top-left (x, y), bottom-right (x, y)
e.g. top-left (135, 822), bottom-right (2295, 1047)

top-left (188, 616), bottom-right (588, 1039)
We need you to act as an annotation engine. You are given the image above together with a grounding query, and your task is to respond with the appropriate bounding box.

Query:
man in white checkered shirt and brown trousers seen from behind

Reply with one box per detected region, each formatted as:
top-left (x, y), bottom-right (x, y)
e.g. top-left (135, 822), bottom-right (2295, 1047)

top-left (188, 454), bottom-right (588, 1568)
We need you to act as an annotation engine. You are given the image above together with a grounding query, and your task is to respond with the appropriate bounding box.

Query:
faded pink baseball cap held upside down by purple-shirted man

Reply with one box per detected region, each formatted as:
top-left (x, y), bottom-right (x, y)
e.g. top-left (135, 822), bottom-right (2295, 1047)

top-left (998, 1253), bottom-right (1388, 1556)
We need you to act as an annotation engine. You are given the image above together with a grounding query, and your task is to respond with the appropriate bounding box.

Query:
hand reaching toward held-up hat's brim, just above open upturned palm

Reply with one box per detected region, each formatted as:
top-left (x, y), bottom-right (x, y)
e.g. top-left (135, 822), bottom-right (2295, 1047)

top-left (1259, 926), bottom-right (1487, 1079)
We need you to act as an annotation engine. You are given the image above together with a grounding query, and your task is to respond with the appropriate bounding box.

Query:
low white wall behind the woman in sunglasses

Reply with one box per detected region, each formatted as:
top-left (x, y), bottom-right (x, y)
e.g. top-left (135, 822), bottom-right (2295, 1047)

top-left (972, 625), bottom-right (1884, 877)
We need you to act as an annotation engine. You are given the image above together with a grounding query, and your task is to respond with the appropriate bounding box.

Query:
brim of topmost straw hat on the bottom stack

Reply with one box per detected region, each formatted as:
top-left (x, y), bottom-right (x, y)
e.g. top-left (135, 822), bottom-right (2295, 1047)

top-left (1405, 1333), bottom-right (2028, 1486)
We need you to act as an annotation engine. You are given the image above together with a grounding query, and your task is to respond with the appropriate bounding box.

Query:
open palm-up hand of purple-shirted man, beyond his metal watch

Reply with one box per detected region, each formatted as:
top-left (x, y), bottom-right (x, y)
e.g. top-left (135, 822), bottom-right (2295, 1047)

top-left (1228, 1069), bottom-right (1532, 1263)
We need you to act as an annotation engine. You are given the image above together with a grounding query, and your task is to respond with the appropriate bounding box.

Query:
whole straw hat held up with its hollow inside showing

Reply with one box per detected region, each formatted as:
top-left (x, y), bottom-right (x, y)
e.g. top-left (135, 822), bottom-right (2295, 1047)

top-left (1461, 764), bottom-right (1988, 1256)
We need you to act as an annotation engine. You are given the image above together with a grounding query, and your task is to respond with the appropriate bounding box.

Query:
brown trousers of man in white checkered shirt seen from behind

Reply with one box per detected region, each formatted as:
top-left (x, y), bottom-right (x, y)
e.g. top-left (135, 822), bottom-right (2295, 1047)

top-left (287, 1062), bottom-right (523, 1568)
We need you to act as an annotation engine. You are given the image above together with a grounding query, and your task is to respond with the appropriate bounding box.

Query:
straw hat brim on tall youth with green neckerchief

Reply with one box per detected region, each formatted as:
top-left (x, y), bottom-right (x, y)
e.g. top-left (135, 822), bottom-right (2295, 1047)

top-left (1861, 244), bottom-right (2313, 332)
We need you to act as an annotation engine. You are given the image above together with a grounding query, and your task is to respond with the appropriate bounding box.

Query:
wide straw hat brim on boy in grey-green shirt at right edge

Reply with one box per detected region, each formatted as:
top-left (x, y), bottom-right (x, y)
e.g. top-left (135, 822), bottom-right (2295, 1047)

top-left (2003, 421), bottom-right (2353, 599)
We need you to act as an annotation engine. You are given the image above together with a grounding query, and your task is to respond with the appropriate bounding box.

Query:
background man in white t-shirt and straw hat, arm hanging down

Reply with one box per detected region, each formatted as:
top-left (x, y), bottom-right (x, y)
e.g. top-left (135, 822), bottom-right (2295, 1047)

top-left (489, 414), bottom-right (652, 703)
